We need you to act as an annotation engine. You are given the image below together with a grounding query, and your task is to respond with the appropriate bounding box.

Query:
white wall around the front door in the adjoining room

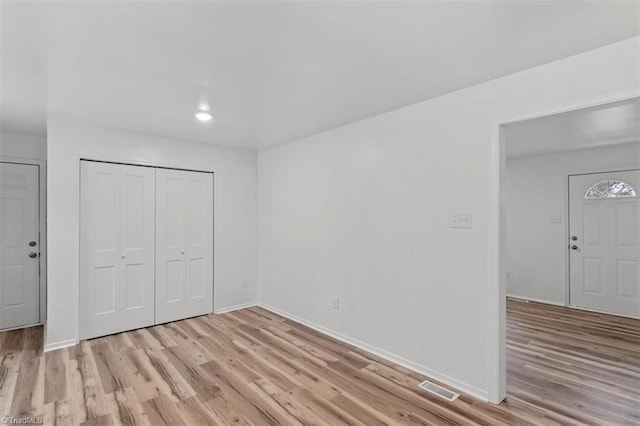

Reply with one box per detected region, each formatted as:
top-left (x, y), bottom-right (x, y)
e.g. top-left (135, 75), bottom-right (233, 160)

top-left (506, 145), bottom-right (640, 305)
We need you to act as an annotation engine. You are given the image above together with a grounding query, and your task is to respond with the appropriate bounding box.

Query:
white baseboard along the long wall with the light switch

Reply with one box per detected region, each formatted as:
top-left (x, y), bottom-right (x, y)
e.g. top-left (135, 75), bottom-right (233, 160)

top-left (257, 302), bottom-right (489, 402)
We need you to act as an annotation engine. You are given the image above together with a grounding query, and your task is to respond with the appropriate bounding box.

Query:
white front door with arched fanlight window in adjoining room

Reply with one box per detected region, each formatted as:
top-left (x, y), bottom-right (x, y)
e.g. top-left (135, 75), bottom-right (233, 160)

top-left (569, 170), bottom-right (640, 317)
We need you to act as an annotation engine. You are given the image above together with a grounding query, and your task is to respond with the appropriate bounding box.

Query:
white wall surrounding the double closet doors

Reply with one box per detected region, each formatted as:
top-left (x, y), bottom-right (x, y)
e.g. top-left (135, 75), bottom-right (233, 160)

top-left (45, 120), bottom-right (257, 349)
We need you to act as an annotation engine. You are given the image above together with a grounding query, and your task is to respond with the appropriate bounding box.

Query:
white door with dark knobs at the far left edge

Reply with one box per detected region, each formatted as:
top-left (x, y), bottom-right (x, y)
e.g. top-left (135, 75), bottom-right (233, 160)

top-left (0, 163), bottom-right (40, 329)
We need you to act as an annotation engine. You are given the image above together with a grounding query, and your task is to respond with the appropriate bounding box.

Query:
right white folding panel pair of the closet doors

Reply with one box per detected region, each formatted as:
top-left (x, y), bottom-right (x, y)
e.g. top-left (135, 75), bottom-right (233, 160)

top-left (156, 169), bottom-right (213, 324)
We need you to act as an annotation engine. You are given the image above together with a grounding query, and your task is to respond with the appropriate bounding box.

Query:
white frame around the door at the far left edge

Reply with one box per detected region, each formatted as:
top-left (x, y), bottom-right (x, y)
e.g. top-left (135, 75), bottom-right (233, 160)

top-left (0, 155), bottom-right (47, 331)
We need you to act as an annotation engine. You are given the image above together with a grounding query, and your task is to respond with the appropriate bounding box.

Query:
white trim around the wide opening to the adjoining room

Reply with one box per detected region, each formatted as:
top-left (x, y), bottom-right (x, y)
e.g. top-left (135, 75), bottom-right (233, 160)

top-left (486, 88), bottom-right (640, 404)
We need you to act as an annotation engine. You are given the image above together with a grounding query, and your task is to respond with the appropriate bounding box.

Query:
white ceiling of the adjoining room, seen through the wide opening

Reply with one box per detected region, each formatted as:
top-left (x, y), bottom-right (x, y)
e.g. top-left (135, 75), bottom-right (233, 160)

top-left (503, 98), bottom-right (640, 158)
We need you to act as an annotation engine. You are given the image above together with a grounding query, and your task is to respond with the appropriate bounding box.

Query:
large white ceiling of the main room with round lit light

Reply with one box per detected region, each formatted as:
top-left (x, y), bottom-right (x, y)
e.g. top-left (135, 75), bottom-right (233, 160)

top-left (0, 0), bottom-right (640, 148)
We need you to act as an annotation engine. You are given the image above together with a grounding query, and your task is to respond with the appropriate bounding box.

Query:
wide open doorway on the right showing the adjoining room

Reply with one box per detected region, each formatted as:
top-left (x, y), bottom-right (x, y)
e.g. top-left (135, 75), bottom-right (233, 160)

top-left (500, 98), bottom-right (640, 423)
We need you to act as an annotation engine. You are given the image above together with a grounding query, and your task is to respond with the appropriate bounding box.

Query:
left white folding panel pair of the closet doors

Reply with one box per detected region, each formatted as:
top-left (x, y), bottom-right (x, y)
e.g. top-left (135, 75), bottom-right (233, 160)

top-left (80, 161), bottom-right (155, 339)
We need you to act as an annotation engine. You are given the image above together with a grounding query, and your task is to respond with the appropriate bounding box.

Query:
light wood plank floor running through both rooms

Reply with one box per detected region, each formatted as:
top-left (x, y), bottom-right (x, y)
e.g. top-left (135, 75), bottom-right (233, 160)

top-left (0, 302), bottom-right (640, 425)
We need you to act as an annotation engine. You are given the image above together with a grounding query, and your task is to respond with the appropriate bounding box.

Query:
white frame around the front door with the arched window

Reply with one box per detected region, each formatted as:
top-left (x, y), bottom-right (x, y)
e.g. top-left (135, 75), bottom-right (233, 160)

top-left (563, 169), bottom-right (640, 319)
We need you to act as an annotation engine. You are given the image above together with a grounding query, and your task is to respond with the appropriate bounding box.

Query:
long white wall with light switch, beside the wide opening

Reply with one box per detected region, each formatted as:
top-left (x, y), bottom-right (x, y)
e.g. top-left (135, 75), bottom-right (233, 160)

top-left (258, 37), bottom-right (640, 400)
